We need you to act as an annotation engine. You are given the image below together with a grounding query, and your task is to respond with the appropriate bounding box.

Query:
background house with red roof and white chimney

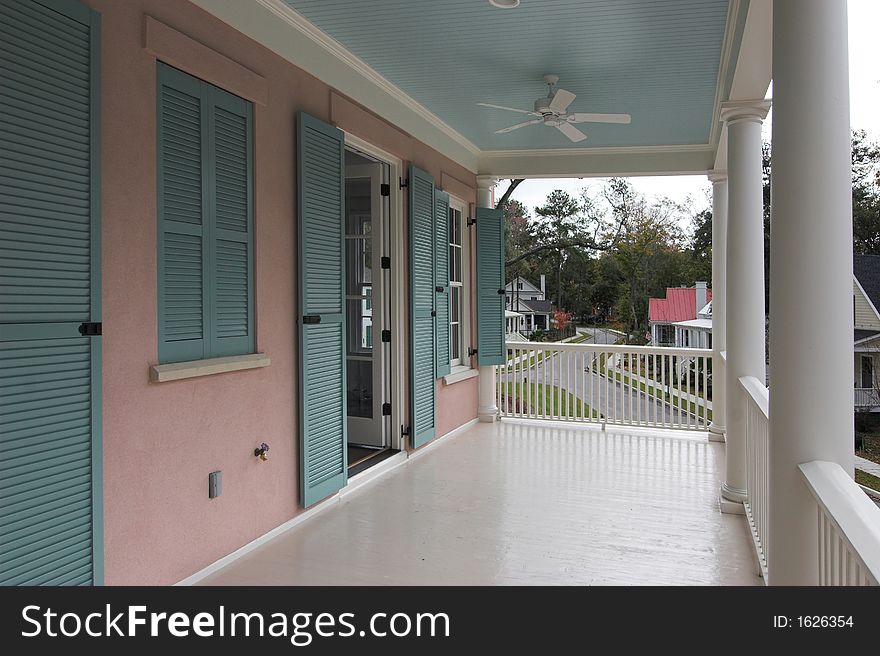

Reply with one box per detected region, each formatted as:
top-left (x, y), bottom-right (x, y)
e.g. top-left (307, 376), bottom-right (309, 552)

top-left (648, 281), bottom-right (712, 348)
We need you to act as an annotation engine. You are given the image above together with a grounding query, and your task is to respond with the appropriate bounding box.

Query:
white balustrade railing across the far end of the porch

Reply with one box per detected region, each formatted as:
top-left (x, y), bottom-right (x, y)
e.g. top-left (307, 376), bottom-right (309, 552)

top-left (496, 342), bottom-right (712, 431)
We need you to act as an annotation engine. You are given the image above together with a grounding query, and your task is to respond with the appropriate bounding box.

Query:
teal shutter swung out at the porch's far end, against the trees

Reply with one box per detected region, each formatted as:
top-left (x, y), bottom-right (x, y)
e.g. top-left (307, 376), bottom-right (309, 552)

top-left (477, 207), bottom-right (504, 365)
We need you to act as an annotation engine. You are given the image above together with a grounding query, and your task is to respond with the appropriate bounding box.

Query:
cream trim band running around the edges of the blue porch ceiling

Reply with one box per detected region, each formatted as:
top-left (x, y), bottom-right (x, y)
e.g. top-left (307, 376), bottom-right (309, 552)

top-left (191, 0), bottom-right (770, 177)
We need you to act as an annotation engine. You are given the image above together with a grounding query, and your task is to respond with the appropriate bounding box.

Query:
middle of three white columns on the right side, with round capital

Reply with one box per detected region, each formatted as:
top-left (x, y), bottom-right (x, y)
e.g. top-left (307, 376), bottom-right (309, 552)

top-left (721, 100), bottom-right (770, 513)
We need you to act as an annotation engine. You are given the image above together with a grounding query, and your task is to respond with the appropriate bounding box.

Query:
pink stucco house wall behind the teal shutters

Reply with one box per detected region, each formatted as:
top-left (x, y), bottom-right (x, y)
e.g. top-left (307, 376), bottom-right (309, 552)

top-left (85, 0), bottom-right (477, 585)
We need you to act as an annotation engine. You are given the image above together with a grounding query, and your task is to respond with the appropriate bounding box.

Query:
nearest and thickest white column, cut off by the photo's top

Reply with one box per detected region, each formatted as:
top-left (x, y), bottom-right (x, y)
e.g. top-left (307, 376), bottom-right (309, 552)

top-left (767, 0), bottom-right (853, 585)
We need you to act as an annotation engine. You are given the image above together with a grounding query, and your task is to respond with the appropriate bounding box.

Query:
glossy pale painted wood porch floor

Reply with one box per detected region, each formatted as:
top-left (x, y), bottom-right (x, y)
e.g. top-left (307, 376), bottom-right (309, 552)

top-left (202, 421), bottom-right (761, 585)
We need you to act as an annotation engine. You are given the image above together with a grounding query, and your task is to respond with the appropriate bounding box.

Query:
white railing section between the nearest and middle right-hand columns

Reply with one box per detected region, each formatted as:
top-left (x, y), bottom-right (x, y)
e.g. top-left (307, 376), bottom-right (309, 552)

top-left (739, 376), bottom-right (770, 583)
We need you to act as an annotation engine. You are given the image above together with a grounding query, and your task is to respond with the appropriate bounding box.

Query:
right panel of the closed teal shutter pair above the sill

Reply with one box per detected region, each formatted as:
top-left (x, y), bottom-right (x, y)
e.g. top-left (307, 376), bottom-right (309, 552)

top-left (205, 86), bottom-right (254, 358)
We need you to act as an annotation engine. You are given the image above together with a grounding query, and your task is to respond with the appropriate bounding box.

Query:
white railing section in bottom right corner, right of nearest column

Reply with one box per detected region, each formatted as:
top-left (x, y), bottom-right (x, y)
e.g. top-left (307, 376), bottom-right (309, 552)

top-left (799, 460), bottom-right (880, 585)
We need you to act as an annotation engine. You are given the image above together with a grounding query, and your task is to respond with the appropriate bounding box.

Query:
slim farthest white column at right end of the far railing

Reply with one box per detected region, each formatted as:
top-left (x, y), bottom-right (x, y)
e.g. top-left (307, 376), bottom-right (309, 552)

top-left (709, 171), bottom-right (727, 442)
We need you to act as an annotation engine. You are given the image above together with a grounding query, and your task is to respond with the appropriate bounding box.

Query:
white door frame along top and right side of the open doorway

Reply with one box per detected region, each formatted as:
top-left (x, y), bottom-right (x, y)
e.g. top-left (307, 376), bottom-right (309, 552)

top-left (342, 133), bottom-right (409, 451)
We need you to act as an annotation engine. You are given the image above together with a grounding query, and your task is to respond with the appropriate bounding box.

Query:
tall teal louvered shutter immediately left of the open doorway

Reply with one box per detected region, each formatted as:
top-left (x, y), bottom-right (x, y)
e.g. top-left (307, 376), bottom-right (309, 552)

top-left (296, 112), bottom-right (348, 507)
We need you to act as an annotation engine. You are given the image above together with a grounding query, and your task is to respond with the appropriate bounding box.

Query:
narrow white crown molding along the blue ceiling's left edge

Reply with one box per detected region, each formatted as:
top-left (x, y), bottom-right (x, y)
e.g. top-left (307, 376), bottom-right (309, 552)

top-left (256, 0), bottom-right (480, 156)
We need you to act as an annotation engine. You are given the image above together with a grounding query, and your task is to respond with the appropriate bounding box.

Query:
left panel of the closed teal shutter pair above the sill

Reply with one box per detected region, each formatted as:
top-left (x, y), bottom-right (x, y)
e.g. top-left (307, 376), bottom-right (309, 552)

top-left (156, 63), bottom-right (205, 362)
